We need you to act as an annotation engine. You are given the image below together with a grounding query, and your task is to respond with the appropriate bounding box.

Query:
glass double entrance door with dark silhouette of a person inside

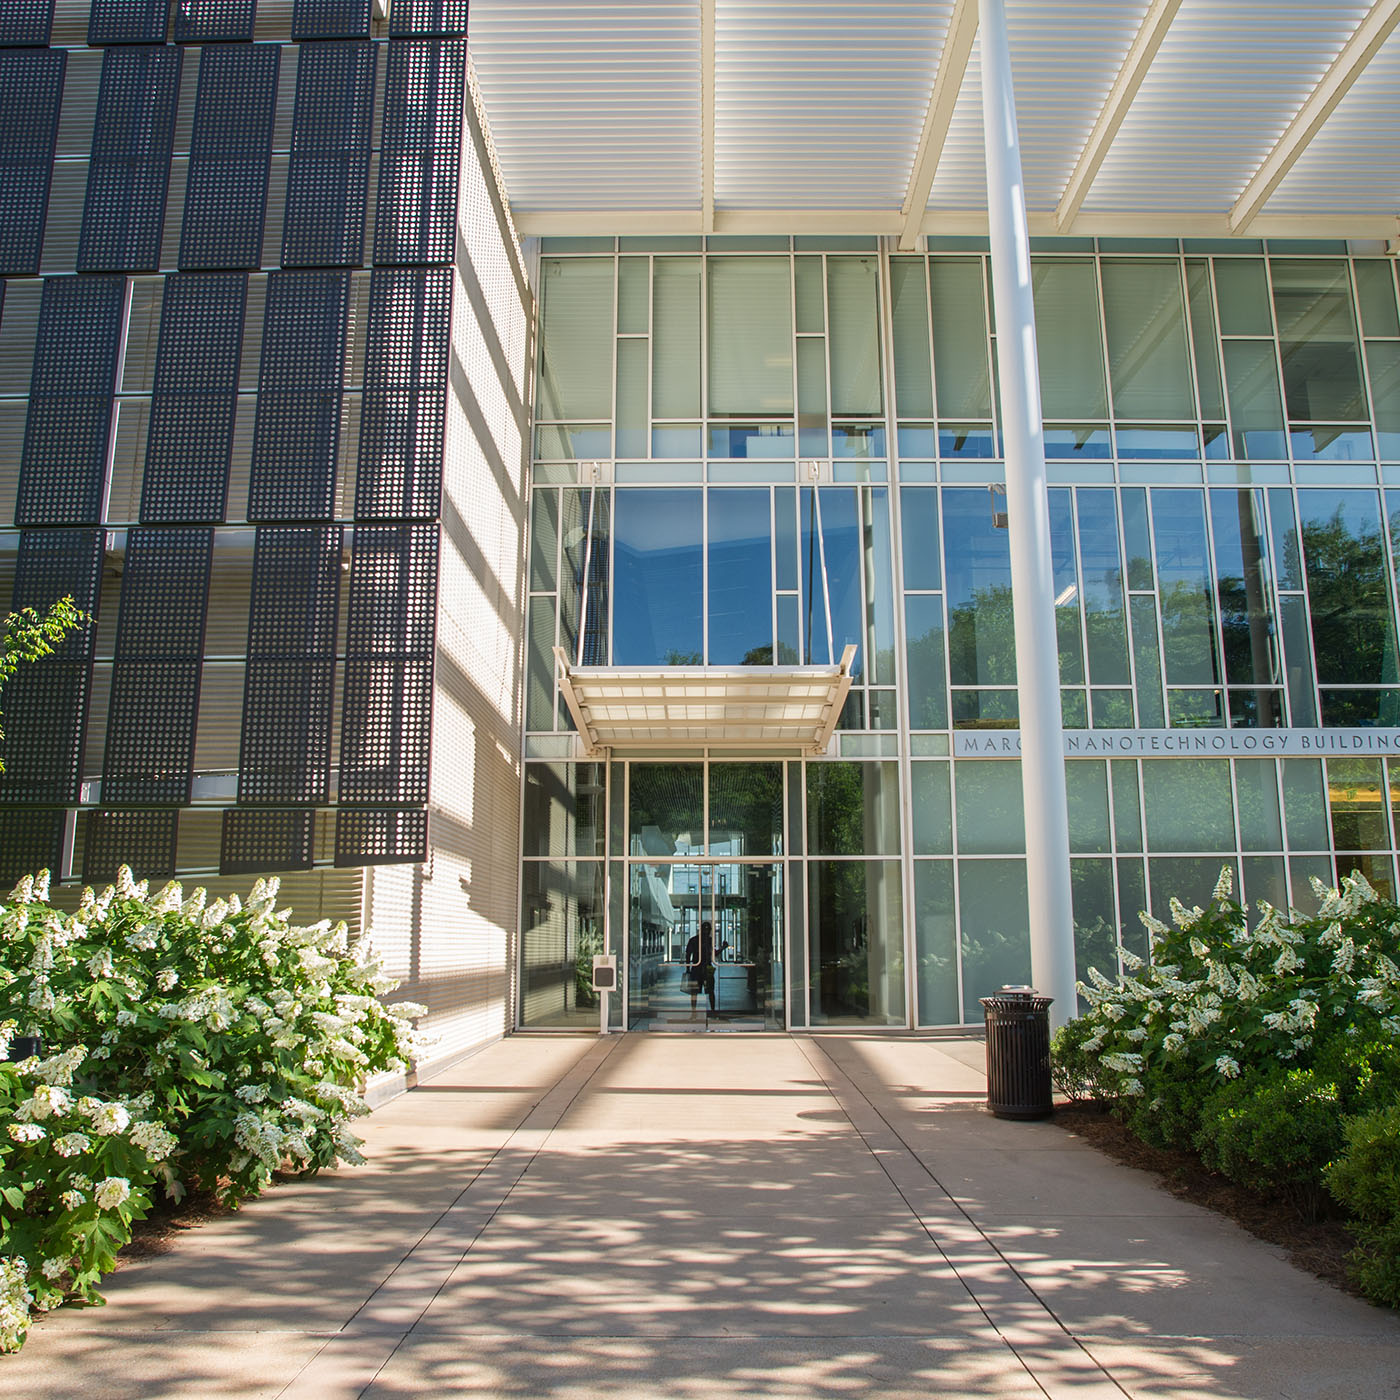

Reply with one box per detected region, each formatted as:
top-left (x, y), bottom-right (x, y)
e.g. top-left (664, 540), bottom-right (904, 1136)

top-left (627, 861), bottom-right (784, 1030)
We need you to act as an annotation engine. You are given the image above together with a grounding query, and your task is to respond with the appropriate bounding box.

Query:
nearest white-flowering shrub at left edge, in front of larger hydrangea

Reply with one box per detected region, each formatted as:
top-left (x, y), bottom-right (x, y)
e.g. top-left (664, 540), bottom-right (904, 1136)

top-left (0, 1036), bottom-right (175, 1351)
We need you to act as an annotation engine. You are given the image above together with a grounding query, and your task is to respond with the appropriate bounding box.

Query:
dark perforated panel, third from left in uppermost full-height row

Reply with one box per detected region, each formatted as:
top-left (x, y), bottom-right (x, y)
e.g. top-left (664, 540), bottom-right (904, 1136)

top-left (179, 43), bottom-right (281, 267)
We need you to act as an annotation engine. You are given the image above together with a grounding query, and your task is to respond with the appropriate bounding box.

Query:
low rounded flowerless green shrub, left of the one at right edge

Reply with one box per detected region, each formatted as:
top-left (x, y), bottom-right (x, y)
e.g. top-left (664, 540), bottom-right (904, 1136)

top-left (1196, 1067), bottom-right (1343, 1218)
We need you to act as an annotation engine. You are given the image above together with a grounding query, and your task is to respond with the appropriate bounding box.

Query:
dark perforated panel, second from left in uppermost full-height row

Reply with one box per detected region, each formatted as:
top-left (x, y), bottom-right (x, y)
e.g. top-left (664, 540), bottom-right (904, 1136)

top-left (78, 48), bottom-right (183, 272)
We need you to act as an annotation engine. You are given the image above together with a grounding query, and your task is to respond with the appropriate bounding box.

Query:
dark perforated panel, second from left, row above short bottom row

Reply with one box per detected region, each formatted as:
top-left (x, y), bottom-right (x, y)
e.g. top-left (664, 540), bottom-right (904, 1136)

top-left (102, 526), bottom-right (214, 804)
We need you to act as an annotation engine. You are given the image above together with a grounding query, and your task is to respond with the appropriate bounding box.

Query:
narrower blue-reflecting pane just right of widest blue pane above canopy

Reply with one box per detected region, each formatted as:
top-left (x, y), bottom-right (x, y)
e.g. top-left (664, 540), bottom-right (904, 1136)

top-left (710, 489), bottom-right (773, 666)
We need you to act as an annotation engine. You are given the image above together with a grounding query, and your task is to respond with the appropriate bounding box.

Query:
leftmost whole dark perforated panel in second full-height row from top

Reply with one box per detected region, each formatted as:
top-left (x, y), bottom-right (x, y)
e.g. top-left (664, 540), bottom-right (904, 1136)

top-left (14, 277), bottom-right (126, 525)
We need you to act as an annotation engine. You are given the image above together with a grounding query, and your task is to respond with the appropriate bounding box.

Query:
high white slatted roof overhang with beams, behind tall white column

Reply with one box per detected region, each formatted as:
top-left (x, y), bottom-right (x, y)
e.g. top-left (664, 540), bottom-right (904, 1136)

top-left (470, 0), bottom-right (1400, 246)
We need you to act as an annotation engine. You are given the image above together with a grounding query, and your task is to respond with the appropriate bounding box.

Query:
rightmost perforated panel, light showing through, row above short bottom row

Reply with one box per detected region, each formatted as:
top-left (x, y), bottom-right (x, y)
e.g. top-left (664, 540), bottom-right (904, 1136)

top-left (340, 525), bottom-right (438, 806)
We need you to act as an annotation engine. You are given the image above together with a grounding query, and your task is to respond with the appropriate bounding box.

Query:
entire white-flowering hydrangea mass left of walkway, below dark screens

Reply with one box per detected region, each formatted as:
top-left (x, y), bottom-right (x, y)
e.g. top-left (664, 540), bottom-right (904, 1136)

top-left (0, 868), bottom-right (424, 1350)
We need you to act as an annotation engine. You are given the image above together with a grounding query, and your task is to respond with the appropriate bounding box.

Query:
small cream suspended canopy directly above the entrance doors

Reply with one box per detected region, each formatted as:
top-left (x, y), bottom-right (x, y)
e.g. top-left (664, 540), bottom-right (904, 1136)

top-left (554, 645), bottom-right (855, 756)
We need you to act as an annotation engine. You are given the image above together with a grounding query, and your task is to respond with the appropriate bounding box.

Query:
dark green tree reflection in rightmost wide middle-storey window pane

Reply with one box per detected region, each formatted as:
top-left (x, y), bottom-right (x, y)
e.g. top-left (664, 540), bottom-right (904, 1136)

top-left (1303, 505), bottom-right (1397, 685)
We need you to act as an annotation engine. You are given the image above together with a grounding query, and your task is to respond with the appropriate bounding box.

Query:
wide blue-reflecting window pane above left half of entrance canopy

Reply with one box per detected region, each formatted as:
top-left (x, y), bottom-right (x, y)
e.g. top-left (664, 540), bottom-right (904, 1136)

top-left (613, 487), bottom-right (704, 666)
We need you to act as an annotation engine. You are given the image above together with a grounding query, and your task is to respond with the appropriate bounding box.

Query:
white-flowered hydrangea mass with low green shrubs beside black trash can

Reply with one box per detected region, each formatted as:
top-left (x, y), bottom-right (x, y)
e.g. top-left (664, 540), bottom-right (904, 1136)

top-left (1053, 868), bottom-right (1400, 1305)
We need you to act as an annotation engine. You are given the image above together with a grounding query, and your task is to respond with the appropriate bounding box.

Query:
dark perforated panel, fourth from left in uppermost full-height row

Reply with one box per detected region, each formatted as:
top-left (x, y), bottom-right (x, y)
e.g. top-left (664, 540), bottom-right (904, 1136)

top-left (281, 42), bottom-right (379, 267)
